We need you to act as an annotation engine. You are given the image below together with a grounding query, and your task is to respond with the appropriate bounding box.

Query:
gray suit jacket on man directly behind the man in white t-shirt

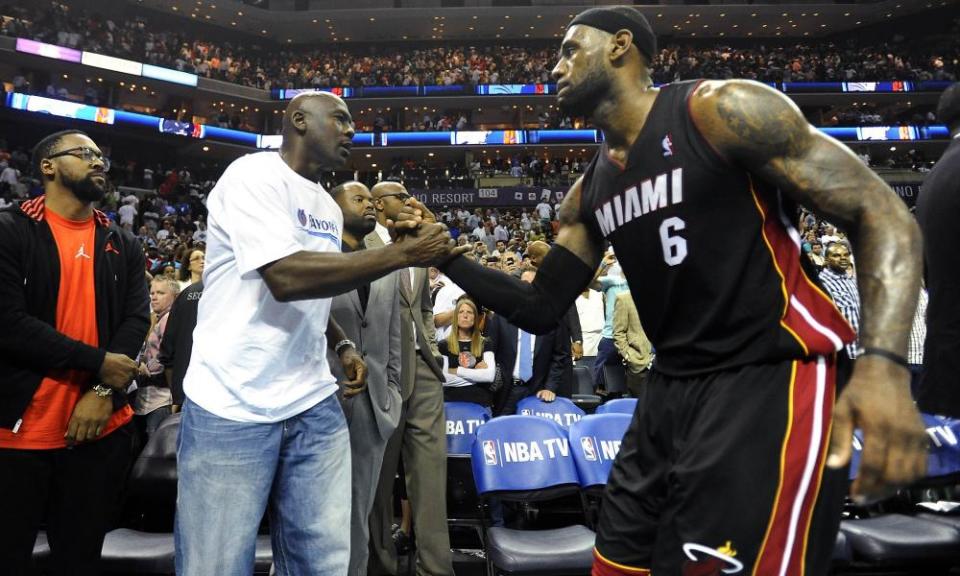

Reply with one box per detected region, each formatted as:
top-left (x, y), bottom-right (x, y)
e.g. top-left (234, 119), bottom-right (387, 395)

top-left (327, 246), bottom-right (401, 441)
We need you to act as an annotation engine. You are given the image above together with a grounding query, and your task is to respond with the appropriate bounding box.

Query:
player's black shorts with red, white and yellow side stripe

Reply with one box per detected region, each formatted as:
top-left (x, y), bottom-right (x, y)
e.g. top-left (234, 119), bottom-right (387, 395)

top-left (593, 357), bottom-right (847, 576)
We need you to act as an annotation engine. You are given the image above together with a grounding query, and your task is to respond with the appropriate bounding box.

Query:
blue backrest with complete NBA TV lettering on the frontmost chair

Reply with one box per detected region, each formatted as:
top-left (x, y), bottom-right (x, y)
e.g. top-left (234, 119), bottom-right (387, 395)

top-left (471, 416), bottom-right (579, 494)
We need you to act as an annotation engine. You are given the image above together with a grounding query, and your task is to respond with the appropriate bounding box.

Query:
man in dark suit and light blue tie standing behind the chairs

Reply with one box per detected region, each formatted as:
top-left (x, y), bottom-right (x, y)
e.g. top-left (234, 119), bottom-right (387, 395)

top-left (488, 269), bottom-right (571, 415)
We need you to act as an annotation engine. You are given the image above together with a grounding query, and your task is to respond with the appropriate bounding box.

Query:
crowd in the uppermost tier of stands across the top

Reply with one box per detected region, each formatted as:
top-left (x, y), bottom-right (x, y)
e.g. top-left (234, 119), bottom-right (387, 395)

top-left (0, 2), bottom-right (960, 89)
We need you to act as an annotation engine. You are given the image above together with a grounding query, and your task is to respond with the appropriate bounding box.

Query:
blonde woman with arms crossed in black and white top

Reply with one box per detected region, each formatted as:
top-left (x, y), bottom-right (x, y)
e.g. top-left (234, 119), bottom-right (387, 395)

top-left (439, 298), bottom-right (496, 406)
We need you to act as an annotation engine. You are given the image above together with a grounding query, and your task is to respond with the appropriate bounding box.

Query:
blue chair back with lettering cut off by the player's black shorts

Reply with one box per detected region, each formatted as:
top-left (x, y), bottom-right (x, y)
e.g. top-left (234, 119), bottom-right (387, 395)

top-left (569, 413), bottom-right (633, 488)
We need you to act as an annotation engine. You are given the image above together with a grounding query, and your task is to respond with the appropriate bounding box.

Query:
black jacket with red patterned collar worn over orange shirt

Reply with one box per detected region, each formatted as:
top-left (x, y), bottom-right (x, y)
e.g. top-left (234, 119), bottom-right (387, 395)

top-left (0, 197), bottom-right (150, 429)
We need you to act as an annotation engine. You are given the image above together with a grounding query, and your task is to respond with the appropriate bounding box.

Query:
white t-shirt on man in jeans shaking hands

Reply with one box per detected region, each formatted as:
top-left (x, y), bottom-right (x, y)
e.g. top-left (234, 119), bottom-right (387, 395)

top-left (183, 152), bottom-right (343, 422)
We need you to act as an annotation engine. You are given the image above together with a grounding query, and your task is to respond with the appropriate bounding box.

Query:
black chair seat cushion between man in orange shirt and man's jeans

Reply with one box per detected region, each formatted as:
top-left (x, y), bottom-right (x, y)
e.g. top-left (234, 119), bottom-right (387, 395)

top-left (101, 528), bottom-right (174, 574)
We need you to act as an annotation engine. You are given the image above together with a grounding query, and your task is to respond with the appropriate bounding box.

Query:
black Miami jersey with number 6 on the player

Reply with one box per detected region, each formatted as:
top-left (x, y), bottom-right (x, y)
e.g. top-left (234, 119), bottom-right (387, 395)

top-left (581, 81), bottom-right (854, 376)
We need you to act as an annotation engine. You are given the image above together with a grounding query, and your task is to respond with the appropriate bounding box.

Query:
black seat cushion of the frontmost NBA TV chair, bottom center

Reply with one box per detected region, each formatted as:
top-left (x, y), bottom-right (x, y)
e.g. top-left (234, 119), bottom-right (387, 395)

top-left (487, 525), bottom-right (597, 576)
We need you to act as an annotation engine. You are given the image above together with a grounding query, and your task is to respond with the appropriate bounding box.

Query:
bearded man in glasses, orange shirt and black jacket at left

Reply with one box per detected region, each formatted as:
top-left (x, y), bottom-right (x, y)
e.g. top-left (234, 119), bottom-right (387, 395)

top-left (0, 130), bottom-right (150, 575)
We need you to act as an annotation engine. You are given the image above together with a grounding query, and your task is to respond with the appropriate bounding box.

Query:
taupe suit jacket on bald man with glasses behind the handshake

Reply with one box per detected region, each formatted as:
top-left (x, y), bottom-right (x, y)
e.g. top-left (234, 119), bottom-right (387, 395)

top-left (364, 231), bottom-right (443, 400)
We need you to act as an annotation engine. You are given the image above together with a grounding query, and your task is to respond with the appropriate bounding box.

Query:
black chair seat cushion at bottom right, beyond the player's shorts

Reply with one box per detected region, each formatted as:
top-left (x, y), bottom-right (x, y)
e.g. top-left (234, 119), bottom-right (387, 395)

top-left (840, 514), bottom-right (960, 564)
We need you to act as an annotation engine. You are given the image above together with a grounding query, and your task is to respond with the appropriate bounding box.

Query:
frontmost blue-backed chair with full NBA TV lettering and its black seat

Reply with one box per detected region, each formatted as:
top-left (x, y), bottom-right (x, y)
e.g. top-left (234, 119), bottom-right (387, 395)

top-left (472, 416), bottom-right (596, 576)
